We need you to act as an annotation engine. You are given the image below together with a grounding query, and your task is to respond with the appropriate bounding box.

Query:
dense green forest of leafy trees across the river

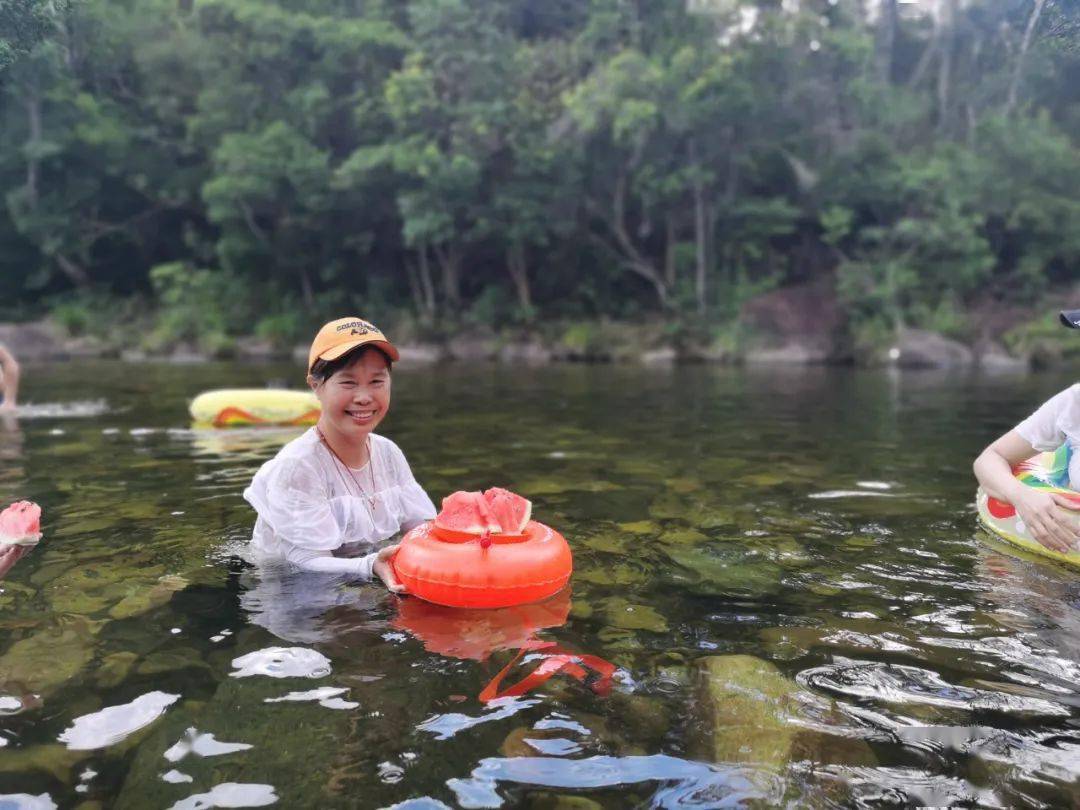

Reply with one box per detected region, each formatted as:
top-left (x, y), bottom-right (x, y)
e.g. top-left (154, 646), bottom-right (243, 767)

top-left (0, 0), bottom-right (1080, 361)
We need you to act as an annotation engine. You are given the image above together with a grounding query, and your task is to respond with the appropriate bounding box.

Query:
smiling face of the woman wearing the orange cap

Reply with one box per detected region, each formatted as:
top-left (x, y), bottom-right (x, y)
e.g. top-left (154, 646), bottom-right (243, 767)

top-left (308, 350), bottom-right (390, 442)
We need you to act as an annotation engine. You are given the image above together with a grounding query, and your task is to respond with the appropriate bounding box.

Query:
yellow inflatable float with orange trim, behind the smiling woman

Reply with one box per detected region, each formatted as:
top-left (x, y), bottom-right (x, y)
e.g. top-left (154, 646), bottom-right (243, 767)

top-left (188, 388), bottom-right (320, 428)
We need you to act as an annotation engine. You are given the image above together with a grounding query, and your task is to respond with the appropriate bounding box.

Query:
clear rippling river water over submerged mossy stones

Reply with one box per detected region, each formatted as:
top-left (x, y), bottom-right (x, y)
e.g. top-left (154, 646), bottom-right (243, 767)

top-left (0, 362), bottom-right (1080, 810)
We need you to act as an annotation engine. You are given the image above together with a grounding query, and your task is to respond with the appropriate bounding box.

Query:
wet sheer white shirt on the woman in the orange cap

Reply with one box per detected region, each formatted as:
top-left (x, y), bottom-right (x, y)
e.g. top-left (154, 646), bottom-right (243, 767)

top-left (244, 428), bottom-right (435, 579)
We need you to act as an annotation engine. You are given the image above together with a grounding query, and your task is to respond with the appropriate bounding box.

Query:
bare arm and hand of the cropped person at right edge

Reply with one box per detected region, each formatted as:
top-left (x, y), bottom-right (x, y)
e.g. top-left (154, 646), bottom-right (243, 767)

top-left (974, 430), bottom-right (1080, 554)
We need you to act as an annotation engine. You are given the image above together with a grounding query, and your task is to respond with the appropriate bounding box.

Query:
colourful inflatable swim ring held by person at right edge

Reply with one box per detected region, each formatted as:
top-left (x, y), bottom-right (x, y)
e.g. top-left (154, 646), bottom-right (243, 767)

top-left (975, 445), bottom-right (1080, 567)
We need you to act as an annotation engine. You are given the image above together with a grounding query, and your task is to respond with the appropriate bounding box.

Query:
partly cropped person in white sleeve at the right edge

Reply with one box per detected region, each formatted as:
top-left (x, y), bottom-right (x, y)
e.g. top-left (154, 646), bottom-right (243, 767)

top-left (975, 310), bottom-right (1080, 554)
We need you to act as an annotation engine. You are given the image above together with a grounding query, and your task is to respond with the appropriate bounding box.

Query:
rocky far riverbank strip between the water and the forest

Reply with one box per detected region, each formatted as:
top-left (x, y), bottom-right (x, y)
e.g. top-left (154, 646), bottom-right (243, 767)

top-left (0, 281), bottom-right (1080, 372)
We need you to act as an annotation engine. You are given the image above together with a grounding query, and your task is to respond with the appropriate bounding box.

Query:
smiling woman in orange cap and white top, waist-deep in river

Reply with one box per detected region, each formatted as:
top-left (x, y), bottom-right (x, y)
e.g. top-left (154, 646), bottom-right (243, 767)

top-left (244, 318), bottom-right (435, 593)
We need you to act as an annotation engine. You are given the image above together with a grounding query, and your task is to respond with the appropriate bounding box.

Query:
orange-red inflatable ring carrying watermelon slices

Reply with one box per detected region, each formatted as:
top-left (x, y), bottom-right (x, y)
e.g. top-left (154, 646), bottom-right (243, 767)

top-left (393, 521), bottom-right (573, 608)
